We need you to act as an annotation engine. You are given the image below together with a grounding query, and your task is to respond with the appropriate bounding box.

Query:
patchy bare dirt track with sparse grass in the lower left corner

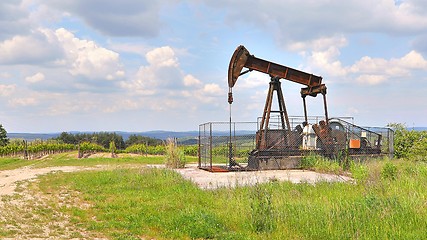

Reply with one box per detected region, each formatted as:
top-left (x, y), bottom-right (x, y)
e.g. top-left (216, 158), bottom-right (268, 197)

top-left (0, 167), bottom-right (106, 239)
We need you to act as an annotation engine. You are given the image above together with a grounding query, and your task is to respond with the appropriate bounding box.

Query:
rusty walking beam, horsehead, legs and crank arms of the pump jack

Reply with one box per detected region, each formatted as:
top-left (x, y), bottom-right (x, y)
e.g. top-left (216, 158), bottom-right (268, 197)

top-left (228, 45), bottom-right (333, 169)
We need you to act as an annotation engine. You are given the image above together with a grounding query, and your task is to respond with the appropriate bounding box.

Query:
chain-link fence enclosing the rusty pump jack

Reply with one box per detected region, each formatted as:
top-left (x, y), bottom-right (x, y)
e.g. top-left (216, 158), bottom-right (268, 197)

top-left (199, 116), bottom-right (394, 171)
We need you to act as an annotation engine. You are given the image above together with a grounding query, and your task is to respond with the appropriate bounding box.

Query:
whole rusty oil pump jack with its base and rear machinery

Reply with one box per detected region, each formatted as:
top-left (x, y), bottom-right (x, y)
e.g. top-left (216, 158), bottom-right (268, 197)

top-left (228, 45), bottom-right (382, 169)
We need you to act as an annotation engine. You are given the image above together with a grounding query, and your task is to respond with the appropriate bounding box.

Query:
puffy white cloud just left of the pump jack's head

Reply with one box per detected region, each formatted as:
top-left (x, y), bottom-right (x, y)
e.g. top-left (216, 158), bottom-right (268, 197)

top-left (117, 46), bottom-right (226, 111)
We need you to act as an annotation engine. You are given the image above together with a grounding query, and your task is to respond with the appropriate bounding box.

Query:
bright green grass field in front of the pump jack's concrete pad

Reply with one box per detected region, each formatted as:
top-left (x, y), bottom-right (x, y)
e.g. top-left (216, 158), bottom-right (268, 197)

top-left (0, 154), bottom-right (427, 239)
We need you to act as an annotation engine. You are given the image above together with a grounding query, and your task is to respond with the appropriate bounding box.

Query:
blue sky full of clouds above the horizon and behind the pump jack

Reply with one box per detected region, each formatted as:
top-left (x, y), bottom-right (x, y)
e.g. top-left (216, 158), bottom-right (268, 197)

top-left (0, 0), bottom-right (427, 132)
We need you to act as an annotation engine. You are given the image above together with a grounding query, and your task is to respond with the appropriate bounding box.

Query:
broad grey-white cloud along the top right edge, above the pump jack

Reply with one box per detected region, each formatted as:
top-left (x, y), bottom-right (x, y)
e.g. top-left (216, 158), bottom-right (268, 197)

top-left (211, 0), bottom-right (427, 45)
